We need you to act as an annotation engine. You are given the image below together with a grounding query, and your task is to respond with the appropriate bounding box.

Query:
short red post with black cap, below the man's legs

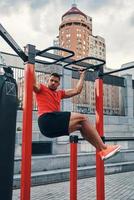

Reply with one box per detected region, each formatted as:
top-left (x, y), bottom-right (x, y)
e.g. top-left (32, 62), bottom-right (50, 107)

top-left (70, 135), bottom-right (78, 200)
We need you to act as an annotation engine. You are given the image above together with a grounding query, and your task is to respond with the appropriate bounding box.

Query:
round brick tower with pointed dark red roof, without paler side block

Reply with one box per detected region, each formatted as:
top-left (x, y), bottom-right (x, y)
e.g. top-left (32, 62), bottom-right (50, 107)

top-left (59, 4), bottom-right (92, 59)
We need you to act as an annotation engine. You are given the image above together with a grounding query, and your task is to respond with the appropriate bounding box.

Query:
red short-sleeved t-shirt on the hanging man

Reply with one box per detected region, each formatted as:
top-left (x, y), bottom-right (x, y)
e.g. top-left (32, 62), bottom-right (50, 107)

top-left (35, 84), bottom-right (65, 116)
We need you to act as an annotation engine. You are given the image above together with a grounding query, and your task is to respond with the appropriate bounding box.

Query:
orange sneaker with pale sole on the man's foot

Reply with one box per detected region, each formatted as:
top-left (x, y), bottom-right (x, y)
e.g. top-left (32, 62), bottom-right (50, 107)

top-left (99, 145), bottom-right (121, 160)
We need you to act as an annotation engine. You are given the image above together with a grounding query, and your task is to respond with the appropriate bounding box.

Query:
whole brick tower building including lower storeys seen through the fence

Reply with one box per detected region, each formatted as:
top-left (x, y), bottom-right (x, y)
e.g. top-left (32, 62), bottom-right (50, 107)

top-left (57, 4), bottom-right (121, 114)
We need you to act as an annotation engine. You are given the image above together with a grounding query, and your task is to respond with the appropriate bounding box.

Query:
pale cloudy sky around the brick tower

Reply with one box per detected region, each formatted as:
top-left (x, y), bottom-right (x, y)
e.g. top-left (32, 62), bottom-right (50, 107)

top-left (0, 0), bottom-right (134, 69)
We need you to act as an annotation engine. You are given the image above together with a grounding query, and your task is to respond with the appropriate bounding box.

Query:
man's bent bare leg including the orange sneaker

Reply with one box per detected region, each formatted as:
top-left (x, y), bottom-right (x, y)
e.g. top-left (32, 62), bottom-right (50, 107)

top-left (69, 113), bottom-right (121, 160)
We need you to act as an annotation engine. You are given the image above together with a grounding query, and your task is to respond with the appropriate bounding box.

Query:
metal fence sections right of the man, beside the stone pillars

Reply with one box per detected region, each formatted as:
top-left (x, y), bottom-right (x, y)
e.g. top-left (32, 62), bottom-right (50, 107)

top-left (72, 72), bottom-right (126, 116)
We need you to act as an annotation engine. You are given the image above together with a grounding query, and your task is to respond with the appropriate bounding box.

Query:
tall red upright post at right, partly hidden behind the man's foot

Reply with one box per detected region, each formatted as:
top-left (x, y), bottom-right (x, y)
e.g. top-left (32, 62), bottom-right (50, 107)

top-left (95, 78), bottom-right (105, 200)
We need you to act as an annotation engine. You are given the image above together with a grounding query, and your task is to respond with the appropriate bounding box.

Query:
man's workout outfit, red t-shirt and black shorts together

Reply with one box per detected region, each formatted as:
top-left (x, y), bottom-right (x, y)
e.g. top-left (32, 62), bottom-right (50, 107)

top-left (35, 84), bottom-right (71, 138)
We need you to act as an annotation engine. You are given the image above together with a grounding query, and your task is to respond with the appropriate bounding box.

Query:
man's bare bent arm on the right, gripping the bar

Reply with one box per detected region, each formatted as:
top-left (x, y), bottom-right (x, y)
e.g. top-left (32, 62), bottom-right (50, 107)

top-left (64, 70), bottom-right (85, 98)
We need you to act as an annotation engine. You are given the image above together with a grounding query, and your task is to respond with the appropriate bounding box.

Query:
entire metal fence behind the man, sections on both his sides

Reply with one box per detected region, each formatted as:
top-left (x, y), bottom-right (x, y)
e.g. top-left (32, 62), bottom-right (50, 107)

top-left (9, 67), bottom-right (126, 116)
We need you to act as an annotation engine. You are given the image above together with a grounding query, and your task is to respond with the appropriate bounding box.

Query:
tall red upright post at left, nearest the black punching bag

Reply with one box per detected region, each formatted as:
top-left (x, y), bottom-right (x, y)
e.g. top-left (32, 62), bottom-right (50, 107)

top-left (20, 64), bottom-right (34, 200)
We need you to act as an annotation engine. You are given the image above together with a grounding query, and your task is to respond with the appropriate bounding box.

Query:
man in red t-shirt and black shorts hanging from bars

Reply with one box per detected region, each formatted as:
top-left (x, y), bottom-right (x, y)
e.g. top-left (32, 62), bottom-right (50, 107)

top-left (33, 70), bottom-right (121, 160)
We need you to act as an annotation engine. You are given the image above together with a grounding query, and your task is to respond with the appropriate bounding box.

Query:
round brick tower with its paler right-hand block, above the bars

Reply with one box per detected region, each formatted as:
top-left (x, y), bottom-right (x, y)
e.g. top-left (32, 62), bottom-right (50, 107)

top-left (59, 4), bottom-right (106, 60)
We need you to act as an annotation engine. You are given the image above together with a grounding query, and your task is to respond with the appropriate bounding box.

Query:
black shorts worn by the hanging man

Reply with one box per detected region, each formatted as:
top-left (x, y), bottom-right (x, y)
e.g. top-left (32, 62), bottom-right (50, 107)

top-left (38, 112), bottom-right (71, 138)
